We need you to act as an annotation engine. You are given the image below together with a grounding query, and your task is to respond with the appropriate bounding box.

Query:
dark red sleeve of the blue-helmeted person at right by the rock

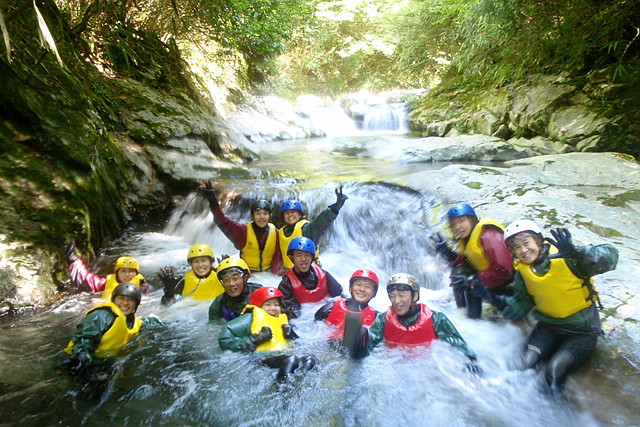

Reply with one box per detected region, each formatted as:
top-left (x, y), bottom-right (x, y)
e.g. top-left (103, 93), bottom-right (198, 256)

top-left (478, 227), bottom-right (513, 289)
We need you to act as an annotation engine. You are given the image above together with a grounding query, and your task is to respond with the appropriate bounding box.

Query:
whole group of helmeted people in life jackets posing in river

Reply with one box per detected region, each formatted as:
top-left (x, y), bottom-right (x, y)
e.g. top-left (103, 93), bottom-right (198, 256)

top-left (65, 182), bottom-right (618, 392)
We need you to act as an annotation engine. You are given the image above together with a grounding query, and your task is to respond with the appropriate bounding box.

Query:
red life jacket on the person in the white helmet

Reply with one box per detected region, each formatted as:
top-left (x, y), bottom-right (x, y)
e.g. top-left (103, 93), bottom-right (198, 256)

top-left (384, 304), bottom-right (438, 347)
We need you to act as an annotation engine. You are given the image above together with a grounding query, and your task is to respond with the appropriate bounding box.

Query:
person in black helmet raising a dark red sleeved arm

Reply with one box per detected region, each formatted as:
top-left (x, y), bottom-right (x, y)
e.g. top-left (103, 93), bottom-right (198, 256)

top-left (202, 181), bottom-right (284, 275)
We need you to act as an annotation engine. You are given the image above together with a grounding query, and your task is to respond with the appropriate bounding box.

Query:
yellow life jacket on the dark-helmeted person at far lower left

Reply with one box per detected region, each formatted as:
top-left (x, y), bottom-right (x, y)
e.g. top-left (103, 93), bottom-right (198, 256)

top-left (64, 302), bottom-right (142, 359)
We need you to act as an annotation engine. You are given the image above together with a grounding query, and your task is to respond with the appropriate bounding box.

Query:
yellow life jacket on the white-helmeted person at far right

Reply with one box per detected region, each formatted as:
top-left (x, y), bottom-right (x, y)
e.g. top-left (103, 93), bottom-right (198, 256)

top-left (514, 246), bottom-right (593, 319)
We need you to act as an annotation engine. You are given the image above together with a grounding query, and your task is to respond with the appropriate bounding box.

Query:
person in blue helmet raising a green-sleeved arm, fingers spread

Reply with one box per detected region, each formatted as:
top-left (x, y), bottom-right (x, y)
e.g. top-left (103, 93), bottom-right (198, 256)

top-left (278, 187), bottom-right (348, 268)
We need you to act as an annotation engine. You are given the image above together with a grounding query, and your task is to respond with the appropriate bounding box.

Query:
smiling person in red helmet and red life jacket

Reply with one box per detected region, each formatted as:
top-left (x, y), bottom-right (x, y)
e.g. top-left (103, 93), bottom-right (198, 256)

top-left (315, 269), bottom-right (380, 340)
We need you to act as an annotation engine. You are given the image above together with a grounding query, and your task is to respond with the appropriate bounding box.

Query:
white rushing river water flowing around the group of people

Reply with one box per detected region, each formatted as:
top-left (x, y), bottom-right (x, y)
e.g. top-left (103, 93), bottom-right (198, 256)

top-left (0, 124), bottom-right (640, 426)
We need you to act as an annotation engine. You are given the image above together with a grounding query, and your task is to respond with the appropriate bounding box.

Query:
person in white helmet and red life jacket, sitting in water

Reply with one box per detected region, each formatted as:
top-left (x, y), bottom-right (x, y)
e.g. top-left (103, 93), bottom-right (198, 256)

top-left (345, 273), bottom-right (479, 372)
